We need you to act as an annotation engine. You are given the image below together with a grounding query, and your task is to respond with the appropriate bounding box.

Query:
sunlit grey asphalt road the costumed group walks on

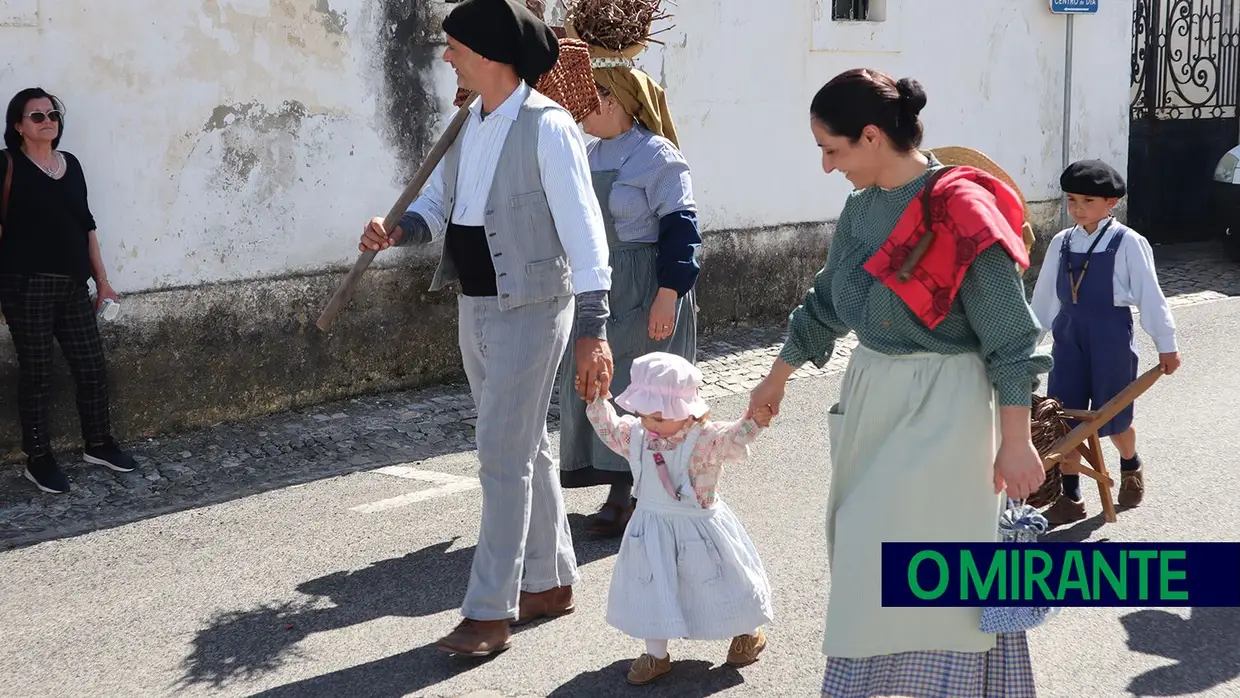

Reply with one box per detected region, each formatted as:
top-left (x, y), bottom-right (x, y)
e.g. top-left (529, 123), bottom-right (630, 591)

top-left (0, 299), bottom-right (1240, 698)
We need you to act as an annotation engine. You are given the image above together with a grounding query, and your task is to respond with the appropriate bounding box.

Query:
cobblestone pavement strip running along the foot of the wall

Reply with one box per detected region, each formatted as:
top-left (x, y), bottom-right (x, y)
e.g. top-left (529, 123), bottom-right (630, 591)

top-left (0, 245), bottom-right (1240, 549)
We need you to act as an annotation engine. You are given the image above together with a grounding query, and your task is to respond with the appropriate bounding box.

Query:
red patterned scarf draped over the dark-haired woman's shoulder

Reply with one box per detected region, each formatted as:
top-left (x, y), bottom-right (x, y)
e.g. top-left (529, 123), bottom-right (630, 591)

top-left (864, 166), bottom-right (1029, 330)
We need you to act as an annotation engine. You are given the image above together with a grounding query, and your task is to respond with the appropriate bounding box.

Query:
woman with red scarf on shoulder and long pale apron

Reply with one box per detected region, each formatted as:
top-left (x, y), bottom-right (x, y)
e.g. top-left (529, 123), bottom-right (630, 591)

top-left (751, 69), bottom-right (1050, 698)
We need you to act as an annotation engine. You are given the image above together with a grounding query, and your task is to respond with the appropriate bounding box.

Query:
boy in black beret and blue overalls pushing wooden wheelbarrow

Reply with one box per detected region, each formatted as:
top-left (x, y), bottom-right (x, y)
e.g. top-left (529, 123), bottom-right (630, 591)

top-left (1032, 160), bottom-right (1179, 526)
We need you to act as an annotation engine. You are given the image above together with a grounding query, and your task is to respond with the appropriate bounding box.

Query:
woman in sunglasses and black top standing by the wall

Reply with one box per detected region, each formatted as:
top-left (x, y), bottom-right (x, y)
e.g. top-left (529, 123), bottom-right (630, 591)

top-left (0, 88), bottom-right (135, 493)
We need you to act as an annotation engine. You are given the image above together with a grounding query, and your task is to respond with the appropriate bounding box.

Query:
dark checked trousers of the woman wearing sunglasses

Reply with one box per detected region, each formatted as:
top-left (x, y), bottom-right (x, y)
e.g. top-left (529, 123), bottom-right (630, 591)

top-left (0, 274), bottom-right (110, 456)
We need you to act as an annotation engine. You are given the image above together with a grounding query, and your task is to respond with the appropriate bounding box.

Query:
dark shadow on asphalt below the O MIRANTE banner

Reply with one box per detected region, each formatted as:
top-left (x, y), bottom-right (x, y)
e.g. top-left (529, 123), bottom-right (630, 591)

top-left (1120, 607), bottom-right (1240, 696)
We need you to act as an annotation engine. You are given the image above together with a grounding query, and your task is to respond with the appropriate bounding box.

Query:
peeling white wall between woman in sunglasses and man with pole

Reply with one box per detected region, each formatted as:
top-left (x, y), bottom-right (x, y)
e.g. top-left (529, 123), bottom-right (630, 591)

top-left (0, 0), bottom-right (450, 294)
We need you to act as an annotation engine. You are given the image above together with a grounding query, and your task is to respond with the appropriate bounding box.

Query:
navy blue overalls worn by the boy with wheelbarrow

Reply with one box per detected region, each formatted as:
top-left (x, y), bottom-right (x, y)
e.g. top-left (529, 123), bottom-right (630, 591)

top-left (1047, 219), bottom-right (1137, 436)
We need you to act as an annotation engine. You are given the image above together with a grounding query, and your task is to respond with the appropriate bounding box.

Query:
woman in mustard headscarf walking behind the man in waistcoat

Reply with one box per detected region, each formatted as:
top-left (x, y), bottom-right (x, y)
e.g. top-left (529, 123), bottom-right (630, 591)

top-left (559, 24), bottom-right (702, 537)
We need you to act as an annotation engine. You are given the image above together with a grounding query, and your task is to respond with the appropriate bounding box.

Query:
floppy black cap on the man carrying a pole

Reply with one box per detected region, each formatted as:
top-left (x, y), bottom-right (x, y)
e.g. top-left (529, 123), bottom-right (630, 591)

top-left (444, 0), bottom-right (559, 86)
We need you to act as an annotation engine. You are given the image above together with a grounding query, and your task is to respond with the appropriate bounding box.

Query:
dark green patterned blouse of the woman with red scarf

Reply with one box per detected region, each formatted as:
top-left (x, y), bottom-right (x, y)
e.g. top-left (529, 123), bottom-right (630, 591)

top-left (780, 156), bottom-right (1052, 407)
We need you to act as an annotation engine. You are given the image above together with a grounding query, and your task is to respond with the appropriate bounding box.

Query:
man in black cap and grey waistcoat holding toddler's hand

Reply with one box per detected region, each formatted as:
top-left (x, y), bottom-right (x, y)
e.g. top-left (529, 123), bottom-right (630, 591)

top-left (360, 0), bottom-right (611, 656)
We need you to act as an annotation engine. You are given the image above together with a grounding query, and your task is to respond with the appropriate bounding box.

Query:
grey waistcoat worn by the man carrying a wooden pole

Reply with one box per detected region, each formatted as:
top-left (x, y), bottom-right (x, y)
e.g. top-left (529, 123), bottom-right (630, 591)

top-left (430, 89), bottom-right (573, 310)
